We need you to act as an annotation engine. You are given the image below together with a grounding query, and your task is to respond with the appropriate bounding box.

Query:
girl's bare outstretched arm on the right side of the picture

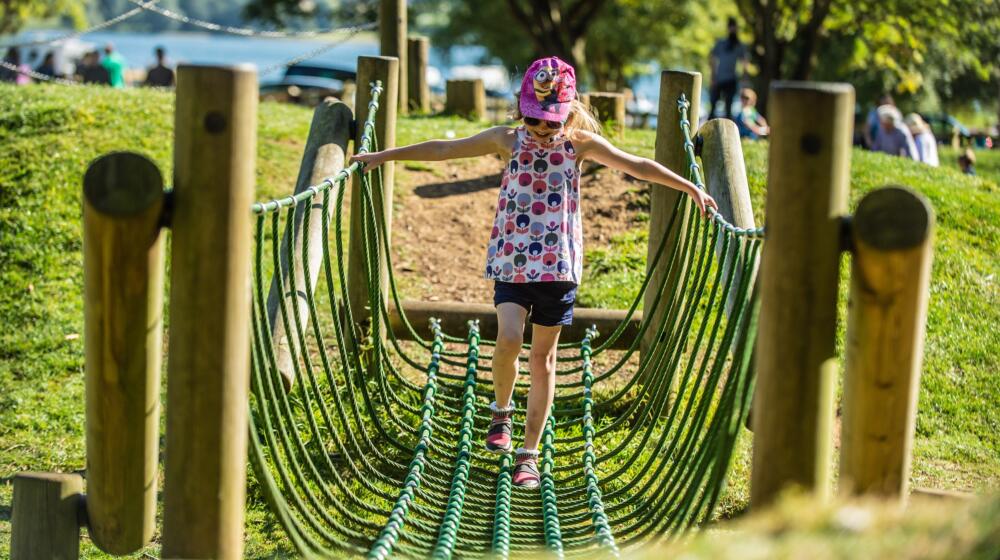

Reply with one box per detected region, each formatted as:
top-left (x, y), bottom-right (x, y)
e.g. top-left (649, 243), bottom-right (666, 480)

top-left (573, 130), bottom-right (719, 214)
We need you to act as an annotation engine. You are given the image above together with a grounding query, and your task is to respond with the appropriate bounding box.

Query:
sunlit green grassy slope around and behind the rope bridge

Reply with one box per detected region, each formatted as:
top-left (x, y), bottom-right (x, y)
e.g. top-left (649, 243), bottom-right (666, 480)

top-left (0, 82), bottom-right (1000, 558)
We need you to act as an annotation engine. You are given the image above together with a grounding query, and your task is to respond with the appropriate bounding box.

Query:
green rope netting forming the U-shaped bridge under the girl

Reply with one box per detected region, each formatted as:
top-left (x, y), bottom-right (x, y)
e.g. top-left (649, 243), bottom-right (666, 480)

top-left (250, 84), bottom-right (762, 558)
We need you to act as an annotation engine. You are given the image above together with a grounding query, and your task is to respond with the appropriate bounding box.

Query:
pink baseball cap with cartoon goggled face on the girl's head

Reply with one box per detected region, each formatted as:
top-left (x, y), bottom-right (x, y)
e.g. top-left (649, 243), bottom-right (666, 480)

top-left (520, 56), bottom-right (576, 122)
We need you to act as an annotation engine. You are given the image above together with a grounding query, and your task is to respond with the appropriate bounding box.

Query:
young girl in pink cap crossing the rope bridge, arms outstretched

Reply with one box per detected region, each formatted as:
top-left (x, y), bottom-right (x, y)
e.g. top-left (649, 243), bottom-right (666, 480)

top-left (351, 57), bottom-right (717, 488)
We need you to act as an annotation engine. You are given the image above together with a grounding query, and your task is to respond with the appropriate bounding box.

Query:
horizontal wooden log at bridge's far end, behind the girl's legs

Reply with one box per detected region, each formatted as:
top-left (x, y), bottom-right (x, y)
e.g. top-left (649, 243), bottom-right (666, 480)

top-left (389, 301), bottom-right (642, 349)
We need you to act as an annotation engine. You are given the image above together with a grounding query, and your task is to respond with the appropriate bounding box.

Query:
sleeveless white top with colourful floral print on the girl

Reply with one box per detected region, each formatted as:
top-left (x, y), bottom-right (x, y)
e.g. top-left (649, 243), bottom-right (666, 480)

top-left (485, 126), bottom-right (583, 284)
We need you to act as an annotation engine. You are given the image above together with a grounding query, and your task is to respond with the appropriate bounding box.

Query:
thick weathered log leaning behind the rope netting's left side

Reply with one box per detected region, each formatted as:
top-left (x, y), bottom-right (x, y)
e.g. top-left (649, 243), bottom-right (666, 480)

top-left (267, 98), bottom-right (353, 389)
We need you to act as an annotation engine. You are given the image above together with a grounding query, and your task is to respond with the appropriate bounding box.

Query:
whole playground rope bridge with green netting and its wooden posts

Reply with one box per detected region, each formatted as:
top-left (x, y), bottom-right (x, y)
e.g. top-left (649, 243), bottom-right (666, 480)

top-left (12, 53), bottom-right (933, 559)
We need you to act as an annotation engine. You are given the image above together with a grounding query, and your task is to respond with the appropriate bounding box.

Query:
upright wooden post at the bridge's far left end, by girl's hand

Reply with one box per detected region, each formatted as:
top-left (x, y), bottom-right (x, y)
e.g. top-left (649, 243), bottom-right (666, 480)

top-left (347, 56), bottom-right (399, 323)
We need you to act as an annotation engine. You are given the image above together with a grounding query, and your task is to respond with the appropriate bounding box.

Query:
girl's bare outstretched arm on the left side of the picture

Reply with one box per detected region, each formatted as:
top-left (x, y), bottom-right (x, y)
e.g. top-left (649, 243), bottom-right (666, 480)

top-left (351, 126), bottom-right (514, 169)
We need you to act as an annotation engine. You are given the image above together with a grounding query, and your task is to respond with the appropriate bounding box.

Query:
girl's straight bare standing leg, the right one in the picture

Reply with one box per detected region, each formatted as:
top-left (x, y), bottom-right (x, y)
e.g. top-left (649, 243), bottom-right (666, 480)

top-left (524, 325), bottom-right (562, 450)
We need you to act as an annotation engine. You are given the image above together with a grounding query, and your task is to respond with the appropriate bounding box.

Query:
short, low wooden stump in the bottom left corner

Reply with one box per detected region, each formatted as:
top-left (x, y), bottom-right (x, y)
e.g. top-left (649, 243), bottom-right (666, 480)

top-left (10, 473), bottom-right (83, 560)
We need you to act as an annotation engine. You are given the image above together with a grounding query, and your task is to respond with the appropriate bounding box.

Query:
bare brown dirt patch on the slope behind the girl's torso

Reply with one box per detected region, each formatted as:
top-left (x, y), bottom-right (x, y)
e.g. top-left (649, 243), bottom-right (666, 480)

top-left (392, 153), bottom-right (648, 303)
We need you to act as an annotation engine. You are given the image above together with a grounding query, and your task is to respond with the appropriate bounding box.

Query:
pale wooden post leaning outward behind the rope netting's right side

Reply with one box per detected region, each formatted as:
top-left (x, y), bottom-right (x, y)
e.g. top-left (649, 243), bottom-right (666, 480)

top-left (698, 119), bottom-right (755, 316)
